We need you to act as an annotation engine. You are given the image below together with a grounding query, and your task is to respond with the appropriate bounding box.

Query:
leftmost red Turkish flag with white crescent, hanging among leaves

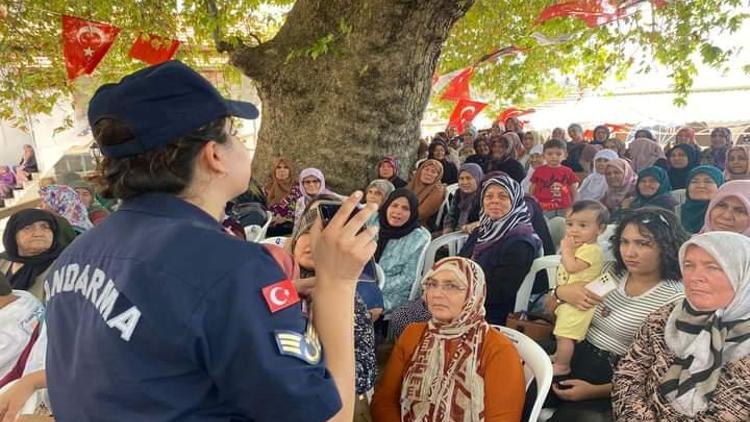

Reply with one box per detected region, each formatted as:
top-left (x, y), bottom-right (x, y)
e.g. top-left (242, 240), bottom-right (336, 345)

top-left (62, 15), bottom-right (120, 80)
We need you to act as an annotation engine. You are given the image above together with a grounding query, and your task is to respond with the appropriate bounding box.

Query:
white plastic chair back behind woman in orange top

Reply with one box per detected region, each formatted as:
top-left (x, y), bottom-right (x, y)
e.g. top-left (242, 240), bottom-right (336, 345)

top-left (492, 325), bottom-right (552, 422)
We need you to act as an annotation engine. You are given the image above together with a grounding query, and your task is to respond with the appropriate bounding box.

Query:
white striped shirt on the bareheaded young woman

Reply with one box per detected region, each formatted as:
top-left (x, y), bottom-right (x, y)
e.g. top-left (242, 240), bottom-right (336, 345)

top-left (586, 265), bottom-right (684, 356)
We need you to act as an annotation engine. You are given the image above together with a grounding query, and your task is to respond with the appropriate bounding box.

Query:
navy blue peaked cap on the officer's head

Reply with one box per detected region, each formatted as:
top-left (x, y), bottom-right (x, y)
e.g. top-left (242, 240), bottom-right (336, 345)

top-left (88, 60), bottom-right (258, 158)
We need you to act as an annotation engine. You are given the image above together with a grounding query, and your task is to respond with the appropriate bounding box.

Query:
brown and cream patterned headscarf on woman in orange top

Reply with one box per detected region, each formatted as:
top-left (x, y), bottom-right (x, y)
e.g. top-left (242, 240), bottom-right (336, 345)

top-left (401, 257), bottom-right (490, 422)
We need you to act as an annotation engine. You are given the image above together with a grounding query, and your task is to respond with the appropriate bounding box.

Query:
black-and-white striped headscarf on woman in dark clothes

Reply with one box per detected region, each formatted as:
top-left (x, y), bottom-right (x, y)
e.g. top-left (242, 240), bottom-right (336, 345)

top-left (472, 173), bottom-right (534, 257)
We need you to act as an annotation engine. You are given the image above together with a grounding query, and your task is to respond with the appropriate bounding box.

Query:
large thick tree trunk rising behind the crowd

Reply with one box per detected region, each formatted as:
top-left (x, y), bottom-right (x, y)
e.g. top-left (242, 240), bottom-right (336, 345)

top-left (231, 0), bottom-right (473, 193)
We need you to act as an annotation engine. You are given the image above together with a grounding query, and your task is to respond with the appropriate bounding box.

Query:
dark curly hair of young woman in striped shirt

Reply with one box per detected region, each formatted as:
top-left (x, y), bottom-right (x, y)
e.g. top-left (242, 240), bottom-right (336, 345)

top-left (610, 207), bottom-right (690, 280)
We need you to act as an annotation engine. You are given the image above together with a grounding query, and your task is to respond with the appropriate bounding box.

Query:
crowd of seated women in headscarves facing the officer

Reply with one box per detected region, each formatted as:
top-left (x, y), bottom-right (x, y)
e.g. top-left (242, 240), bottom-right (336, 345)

top-left (0, 118), bottom-right (750, 421)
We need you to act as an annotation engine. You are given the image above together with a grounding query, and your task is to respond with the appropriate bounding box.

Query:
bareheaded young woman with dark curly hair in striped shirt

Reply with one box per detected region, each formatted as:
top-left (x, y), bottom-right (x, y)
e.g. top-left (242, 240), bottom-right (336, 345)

top-left (547, 208), bottom-right (688, 422)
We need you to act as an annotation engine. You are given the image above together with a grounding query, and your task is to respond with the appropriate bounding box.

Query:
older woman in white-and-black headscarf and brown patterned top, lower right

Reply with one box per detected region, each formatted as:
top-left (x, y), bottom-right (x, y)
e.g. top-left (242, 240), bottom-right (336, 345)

top-left (612, 232), bottom-right (750, 422)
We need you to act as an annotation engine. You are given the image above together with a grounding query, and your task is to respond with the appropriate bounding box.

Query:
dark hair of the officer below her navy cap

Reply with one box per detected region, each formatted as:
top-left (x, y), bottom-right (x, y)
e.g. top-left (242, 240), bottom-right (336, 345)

top-left (92, 117), bottom-right (229, 199)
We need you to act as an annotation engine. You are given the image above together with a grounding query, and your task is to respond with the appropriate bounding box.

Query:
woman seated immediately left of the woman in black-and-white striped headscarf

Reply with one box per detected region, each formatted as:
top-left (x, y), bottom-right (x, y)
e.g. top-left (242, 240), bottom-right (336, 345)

top-left (443, 163), bottom-right (484, 234)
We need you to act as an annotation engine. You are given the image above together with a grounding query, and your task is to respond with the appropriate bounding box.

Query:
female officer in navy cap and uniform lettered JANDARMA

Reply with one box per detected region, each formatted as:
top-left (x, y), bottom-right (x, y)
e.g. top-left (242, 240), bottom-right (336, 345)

top-left (45, 61), bottom-right (375, 422)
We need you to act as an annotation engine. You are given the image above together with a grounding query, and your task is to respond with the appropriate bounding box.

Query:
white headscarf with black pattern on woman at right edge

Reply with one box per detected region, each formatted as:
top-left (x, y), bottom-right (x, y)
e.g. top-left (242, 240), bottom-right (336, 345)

top-left (659, 232), bottom-right (750, 417)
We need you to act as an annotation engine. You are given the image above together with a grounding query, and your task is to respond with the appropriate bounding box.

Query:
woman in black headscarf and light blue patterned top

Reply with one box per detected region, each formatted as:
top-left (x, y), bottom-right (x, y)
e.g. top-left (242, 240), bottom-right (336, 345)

top-left (375, 188), bottom-right (430, 313)
